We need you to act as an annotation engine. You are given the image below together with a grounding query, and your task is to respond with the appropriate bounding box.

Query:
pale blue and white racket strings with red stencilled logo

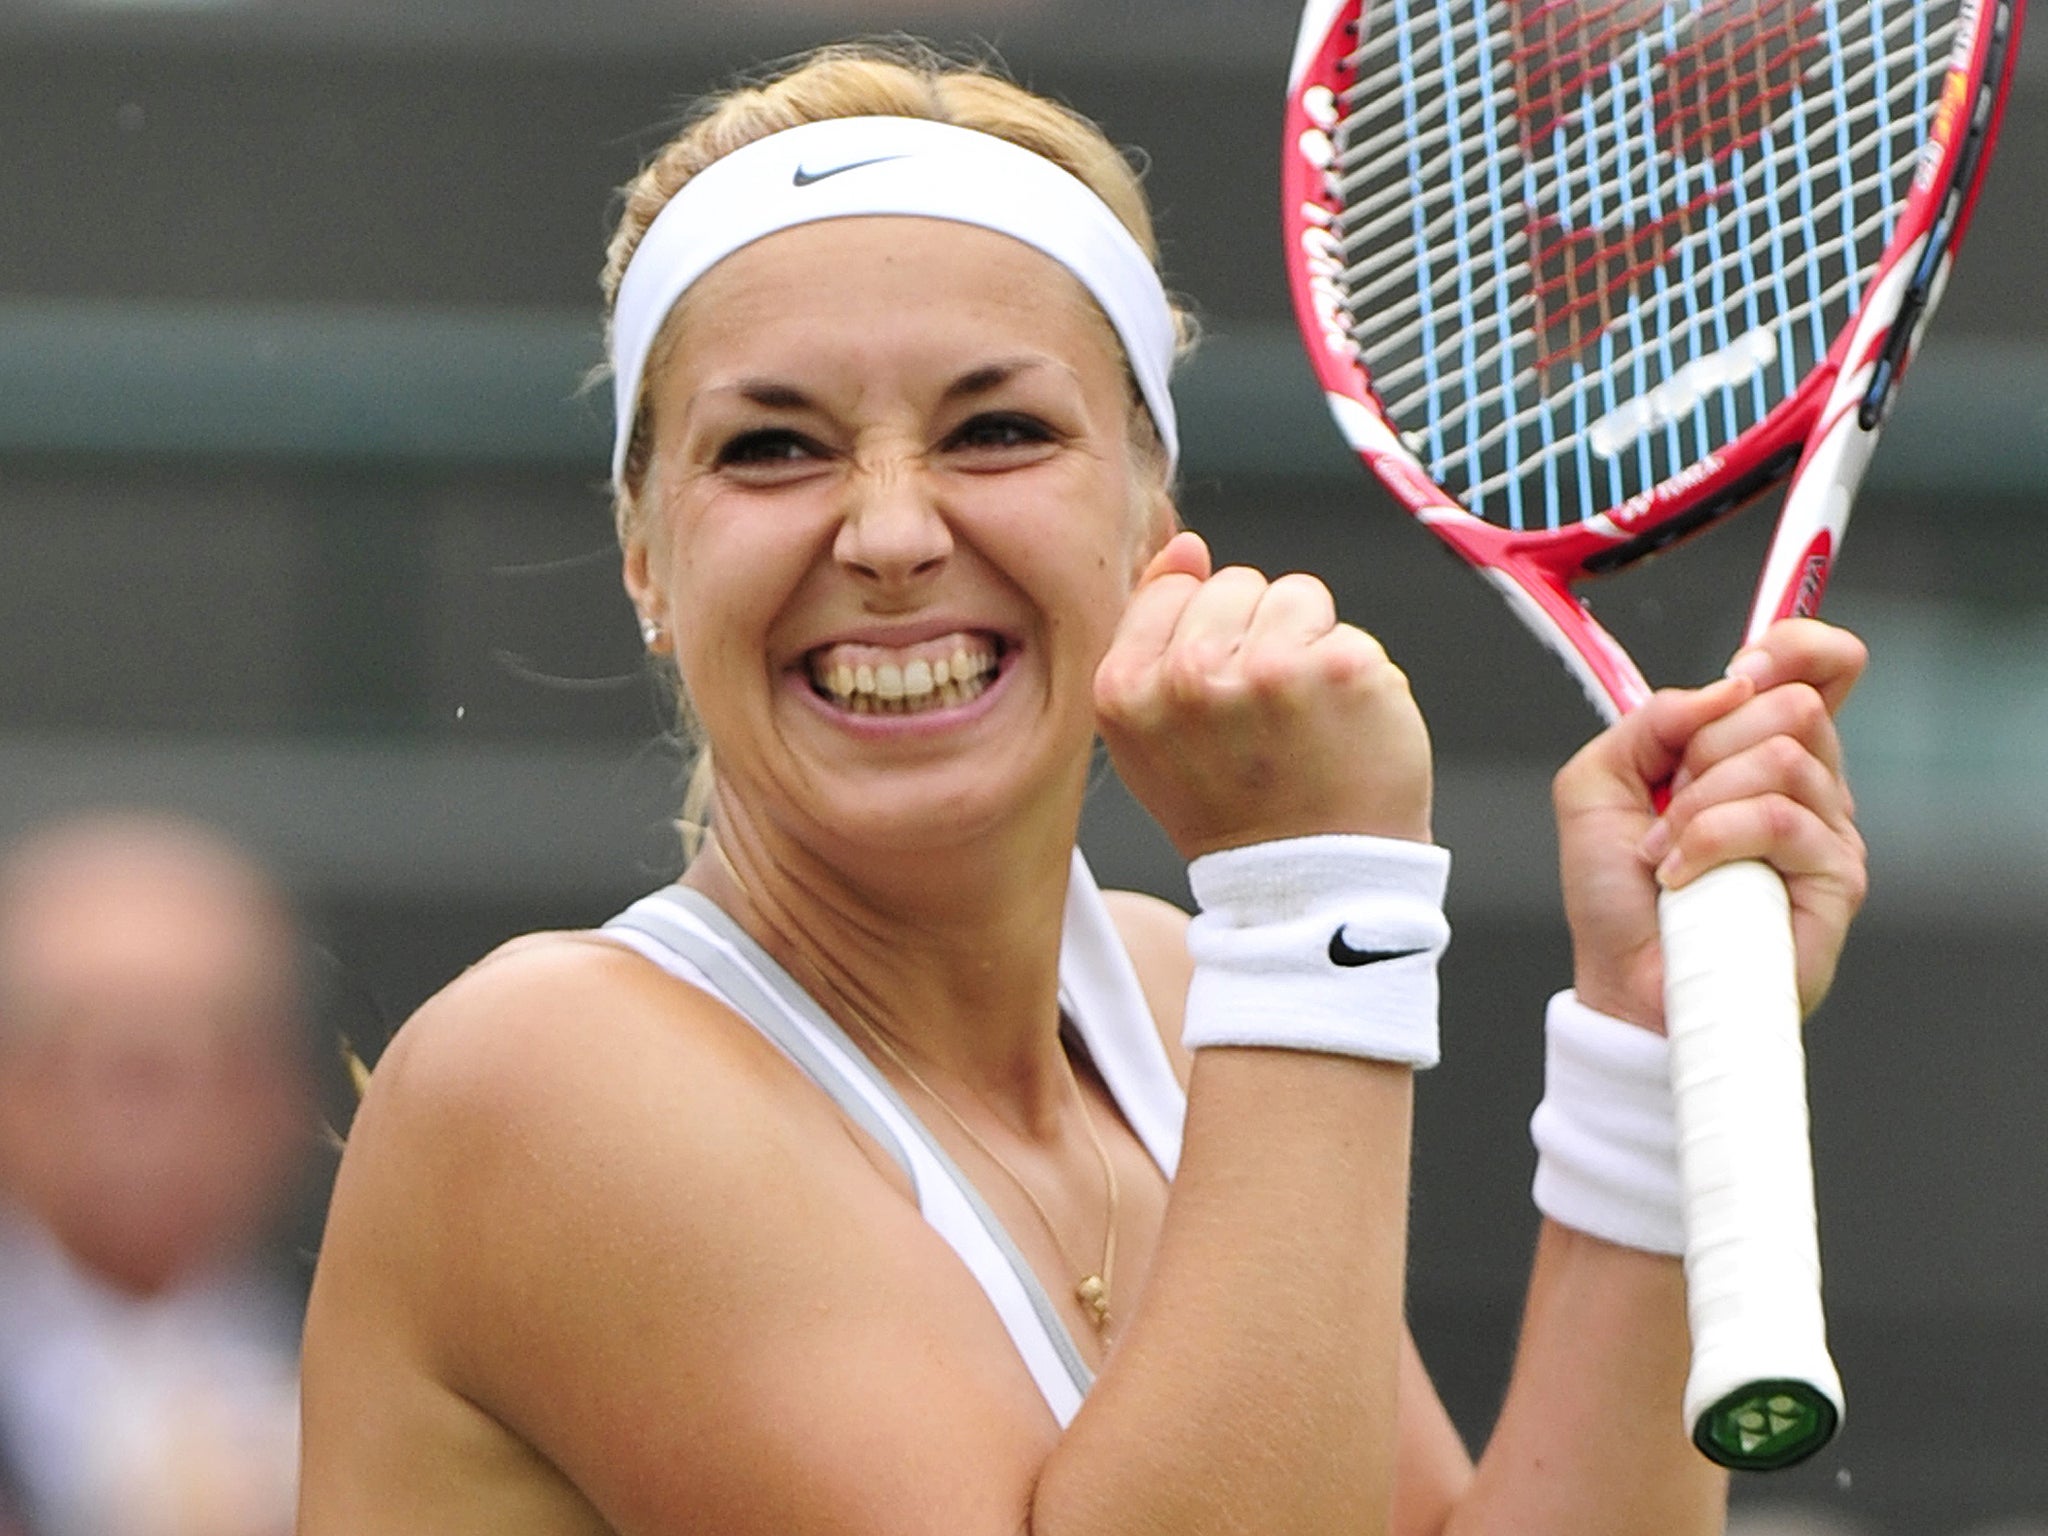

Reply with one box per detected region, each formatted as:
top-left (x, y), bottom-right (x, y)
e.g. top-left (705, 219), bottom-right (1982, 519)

top-left (1329, 0), bottom-right (1958, 526)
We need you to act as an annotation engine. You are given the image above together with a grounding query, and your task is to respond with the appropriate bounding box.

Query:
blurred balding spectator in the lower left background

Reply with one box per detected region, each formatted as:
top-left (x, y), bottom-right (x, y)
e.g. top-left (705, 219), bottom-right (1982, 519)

top-left (0, 815), bottom-right (309, 1536)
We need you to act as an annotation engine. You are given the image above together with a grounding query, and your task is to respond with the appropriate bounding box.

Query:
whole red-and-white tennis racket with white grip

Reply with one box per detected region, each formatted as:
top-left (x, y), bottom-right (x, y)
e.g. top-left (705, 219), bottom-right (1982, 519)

top-left (1282, 0), bottom-right (2021, 1470)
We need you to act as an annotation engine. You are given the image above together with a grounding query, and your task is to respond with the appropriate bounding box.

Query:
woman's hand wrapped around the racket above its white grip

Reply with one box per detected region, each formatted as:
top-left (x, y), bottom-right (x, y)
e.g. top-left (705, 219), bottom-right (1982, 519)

top-left (1554, 618), bottom-right (1868, 1030)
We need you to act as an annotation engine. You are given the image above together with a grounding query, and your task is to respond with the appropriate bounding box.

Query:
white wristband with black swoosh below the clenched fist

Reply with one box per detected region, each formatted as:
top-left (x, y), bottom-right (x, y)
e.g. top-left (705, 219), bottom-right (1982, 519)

top-left (1182, 836), bottom-right (1450, 1067)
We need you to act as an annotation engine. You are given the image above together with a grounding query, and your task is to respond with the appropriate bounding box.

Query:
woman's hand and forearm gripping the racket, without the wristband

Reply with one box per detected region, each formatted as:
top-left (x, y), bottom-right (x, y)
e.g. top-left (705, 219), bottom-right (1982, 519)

top-left (1450, 621), bottom-right (1864, 1536)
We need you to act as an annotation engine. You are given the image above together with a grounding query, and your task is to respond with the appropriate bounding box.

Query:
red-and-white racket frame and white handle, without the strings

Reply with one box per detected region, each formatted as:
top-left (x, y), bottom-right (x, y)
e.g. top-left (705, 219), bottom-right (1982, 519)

top-left (1280, 0), bottom-right (2023, 1470)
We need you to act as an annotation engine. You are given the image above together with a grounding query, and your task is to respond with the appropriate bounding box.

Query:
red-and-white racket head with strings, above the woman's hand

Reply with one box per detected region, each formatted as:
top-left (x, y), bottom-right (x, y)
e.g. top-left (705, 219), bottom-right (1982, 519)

top-left (1282, 0), bottom-right (2019, 715)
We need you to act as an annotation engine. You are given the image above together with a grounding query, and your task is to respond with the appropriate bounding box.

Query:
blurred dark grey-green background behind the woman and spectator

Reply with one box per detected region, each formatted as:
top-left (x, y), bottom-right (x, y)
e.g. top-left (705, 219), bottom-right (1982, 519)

top-left (0, 0), bottom-right (2048, 1536)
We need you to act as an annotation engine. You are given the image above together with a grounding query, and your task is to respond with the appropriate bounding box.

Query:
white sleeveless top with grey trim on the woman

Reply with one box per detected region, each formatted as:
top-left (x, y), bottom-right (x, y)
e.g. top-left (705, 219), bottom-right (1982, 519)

top-left (600, 850), bottom-right (1186, 1425)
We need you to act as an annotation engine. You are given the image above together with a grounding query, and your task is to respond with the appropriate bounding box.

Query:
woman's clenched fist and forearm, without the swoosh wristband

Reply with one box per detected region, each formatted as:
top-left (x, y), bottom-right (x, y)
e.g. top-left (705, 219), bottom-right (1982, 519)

top-left (1032, 535), bottom-right (1430, 1536)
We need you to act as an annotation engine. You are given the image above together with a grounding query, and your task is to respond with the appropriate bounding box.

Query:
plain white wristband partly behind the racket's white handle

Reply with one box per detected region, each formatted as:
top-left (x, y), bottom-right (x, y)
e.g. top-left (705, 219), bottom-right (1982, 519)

top-left (1530, 991), bottom-right (1686, 1253)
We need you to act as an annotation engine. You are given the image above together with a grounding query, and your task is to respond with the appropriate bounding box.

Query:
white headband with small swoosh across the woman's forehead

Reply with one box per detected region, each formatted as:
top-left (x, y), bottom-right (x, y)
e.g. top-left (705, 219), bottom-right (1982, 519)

top-left (612, 117), bottom-right (1180, 485)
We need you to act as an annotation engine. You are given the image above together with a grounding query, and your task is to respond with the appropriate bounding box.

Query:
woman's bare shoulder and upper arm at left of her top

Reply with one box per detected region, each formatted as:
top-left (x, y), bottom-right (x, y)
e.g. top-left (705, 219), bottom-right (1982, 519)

top-left (301, 936), bottom-right (1044, 1536)
